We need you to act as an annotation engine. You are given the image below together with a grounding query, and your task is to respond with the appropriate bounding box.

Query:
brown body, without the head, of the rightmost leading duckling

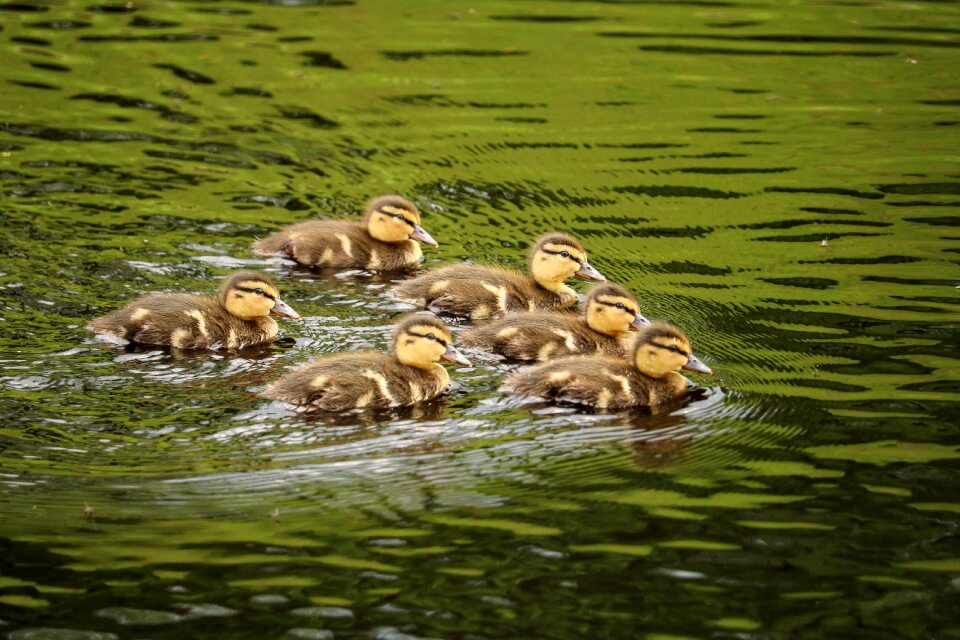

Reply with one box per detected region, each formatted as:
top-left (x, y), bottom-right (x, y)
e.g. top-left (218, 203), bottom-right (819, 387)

top-left (503, 356), bottom-right (689, 409)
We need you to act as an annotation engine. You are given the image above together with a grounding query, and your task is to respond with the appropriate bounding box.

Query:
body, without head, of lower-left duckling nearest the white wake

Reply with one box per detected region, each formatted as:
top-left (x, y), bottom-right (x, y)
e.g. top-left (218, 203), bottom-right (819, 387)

top-left (263, 351), bottom-right (450, 411)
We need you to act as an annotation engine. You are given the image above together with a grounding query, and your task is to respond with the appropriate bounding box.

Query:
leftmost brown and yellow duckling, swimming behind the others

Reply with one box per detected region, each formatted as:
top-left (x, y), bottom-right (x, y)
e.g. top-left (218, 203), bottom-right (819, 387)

top-left (87, 271), bottom-right (300, 349)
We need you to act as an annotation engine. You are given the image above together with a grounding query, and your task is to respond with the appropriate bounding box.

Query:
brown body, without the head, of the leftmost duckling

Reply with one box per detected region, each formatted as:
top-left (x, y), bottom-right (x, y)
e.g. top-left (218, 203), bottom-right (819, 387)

top-left (87, 293), bottom-right (278, 349)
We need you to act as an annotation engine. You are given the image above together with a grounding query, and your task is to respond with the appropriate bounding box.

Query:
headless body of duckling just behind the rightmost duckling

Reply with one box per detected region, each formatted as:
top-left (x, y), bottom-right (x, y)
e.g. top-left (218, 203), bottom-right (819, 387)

top-left (459, 312), bottom-right (625, 361)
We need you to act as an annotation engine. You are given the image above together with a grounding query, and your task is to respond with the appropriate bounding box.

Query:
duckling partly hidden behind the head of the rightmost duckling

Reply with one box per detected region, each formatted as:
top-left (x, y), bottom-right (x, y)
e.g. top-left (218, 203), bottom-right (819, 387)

top-left (460, 284), bottom-right (650, 361)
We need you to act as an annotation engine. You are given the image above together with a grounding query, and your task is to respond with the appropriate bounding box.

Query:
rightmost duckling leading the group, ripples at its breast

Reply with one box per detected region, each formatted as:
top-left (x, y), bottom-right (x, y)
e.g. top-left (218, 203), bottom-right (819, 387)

top-left (503, 323), bottom-right (713, 409)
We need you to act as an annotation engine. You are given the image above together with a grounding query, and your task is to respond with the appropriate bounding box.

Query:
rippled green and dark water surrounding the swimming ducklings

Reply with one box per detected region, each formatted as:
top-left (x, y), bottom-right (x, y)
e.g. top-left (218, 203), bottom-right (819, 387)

top-left (0, 0), bottom-right (960, 640)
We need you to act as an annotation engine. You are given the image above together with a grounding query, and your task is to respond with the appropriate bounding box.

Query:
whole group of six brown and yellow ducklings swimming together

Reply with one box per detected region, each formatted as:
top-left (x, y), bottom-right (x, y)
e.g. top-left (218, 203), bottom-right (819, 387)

top-left (87, 195), bottom-right (712, 411)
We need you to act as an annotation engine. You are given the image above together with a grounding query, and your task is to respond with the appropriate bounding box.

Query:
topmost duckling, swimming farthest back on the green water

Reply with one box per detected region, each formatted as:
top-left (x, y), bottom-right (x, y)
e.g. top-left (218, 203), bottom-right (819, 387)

top-left (253, 196), bottom-right (437, 271)
